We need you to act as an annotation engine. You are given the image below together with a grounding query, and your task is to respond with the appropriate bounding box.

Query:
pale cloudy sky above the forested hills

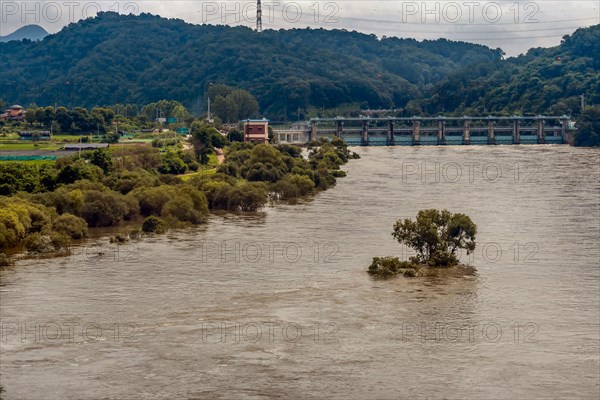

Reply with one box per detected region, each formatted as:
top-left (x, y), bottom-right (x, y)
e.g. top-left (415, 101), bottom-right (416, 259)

top-left (0, 0), bottom-right (600, 56)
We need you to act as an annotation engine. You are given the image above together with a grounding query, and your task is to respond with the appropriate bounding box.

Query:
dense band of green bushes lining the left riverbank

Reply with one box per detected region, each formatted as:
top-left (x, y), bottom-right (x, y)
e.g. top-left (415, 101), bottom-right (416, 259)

top-left (0, 137), bottom-right (356, 262)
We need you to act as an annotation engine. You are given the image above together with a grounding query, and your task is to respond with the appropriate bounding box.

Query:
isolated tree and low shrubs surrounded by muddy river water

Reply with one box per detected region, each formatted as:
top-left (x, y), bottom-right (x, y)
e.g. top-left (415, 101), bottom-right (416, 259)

top-left (368, 209), bottom-right (477, 278)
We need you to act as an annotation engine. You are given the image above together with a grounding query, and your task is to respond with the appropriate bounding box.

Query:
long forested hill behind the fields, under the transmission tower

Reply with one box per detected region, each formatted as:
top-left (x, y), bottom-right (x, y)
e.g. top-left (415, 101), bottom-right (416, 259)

top-left (0, 13), bottom-right (502, 115)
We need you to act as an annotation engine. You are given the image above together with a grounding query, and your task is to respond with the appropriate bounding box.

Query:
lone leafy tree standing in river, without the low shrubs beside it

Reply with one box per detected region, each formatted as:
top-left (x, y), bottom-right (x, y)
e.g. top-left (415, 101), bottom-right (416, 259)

top-left (392, 209), bottom-right (477, 266)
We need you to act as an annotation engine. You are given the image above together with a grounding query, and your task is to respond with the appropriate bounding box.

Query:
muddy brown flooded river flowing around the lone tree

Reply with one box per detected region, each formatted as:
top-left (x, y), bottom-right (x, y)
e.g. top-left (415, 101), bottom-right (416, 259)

top-left (0, 145), bottom-right (600, 399)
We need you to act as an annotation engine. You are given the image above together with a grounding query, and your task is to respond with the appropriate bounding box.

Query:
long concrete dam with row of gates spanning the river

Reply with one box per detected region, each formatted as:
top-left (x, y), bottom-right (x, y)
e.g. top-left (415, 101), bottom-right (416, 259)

top-left (274, 115), bottom-right (574, 146)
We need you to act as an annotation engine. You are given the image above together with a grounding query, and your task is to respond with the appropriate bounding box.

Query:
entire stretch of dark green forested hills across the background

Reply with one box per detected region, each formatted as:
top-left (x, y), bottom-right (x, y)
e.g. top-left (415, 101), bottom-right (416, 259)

top-left (0, 13), bottom-right (600, 120)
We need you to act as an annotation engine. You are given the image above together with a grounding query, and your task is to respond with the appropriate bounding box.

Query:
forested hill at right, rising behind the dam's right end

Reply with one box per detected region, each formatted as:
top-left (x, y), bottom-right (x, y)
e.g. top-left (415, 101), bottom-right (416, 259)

top-left (422, 25), bottom-right (600, 115)
